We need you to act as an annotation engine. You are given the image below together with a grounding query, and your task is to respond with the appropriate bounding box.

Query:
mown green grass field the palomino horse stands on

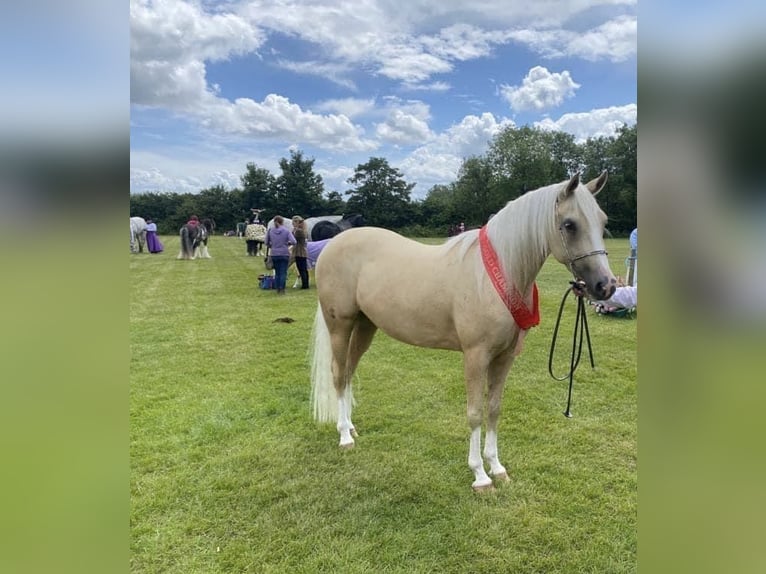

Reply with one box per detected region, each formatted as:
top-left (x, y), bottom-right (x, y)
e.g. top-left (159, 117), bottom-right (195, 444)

top-left (130, 236), bottom-right (637, 574)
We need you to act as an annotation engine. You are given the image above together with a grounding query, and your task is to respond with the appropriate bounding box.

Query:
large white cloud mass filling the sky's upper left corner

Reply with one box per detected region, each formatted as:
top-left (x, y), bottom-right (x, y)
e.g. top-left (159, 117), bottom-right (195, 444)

top-left (131, 0), bottom-right (384, 151)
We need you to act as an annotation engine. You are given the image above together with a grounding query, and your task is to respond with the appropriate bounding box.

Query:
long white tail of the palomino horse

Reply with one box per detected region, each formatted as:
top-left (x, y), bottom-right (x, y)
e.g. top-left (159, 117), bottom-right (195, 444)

top-left (309, 304), bottom-right (338, 423)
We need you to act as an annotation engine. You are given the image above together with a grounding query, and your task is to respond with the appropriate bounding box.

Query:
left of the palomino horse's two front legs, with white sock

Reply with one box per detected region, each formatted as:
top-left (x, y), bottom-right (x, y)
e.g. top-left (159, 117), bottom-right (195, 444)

top-left (464, 352), bottom-right (492, 492)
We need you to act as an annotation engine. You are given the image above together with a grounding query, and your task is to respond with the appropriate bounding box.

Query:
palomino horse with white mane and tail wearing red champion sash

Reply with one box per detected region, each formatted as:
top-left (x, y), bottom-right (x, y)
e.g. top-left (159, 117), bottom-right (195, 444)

top-left (311, 172), bottom-right (616, 490)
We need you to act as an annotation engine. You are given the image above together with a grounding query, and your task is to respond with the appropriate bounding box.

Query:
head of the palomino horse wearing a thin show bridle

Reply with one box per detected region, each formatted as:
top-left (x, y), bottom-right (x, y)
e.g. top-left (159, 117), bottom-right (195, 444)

top-left (550, 171), bottom-right (617, 300)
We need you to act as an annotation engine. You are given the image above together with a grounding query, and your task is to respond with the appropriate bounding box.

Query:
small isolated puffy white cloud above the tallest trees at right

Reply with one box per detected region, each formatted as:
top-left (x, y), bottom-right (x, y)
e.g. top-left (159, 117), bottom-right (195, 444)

top-left (500, 66), bottom-right (580, 112)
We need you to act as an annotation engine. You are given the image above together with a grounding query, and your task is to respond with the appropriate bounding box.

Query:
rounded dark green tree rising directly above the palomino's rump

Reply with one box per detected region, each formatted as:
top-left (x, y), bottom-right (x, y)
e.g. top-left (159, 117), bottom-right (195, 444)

top-left (346, 157), bottom-right (415, 229)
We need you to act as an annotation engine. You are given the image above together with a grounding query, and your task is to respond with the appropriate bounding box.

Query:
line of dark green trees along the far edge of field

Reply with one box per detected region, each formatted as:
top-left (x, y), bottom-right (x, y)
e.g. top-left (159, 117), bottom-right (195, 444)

top-left (130, 126), bottom-right (637, 237)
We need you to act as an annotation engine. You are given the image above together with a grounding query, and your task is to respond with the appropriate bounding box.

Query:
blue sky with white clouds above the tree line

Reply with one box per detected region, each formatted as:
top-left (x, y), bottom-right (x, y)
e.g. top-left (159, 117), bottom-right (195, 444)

top-left (130, 0), bottom-right (637, 198)
